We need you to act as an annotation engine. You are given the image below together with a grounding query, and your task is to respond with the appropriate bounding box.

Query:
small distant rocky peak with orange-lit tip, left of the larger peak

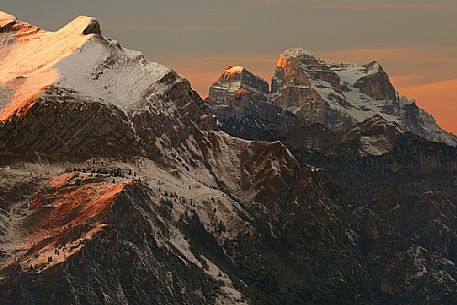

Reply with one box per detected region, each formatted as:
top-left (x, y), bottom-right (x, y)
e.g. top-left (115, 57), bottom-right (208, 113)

top-left (209, 66), bottom-right (269, 105)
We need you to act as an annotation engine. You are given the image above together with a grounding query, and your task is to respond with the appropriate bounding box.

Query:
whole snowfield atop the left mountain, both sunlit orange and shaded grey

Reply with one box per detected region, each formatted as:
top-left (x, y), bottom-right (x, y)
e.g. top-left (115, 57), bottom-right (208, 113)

top-left (0, 12), bottom-right (176, 120)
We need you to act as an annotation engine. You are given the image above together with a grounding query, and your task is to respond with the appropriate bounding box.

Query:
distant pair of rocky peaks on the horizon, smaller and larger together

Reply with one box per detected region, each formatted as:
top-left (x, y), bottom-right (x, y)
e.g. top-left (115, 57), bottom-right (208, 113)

top-left (208, 49), bottom-right (457, 146)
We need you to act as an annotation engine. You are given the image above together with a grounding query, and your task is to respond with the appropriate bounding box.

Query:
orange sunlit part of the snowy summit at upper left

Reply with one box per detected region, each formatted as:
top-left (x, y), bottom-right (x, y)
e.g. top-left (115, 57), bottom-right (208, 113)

top-left (0, 12), bottom-right (100, 121)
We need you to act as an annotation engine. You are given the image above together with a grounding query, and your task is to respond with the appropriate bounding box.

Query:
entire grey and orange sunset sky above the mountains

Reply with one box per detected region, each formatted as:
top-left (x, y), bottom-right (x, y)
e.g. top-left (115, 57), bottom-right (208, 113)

top-left (0, 0), bottom-right (457, 134)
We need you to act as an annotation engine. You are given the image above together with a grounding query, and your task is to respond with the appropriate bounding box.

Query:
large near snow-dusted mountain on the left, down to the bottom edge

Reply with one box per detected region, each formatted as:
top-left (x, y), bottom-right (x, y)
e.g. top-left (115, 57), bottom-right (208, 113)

top-left (0, 13), bottom-right (299, 304)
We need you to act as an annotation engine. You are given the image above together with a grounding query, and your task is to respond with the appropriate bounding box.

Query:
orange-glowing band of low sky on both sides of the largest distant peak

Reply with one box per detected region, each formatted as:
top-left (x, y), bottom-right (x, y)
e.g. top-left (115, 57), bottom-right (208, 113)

top-left (155, 47), bottom-right (457, 134)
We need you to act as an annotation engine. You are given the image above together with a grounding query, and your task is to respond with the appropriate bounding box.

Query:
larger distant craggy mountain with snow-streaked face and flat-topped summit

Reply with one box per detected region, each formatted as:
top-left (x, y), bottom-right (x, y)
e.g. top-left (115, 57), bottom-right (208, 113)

top-left (270, 49), bottom-right (457, 146)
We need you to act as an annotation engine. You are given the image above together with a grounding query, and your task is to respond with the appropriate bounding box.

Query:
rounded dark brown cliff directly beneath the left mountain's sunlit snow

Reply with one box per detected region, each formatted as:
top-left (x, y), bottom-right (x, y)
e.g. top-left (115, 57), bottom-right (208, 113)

top-left (0, 87), bottom-right (138, 160)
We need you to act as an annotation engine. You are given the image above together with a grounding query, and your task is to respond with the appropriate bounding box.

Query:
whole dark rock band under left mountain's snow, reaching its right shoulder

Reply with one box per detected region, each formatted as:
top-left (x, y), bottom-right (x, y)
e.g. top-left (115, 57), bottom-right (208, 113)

top-left (0, 72), bottom-right (218, 161)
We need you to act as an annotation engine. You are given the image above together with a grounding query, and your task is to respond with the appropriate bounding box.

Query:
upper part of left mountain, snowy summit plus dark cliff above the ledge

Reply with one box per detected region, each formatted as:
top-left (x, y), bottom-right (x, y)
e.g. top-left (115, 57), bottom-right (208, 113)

top-left (0, 13), bottom-right (217, 163)
